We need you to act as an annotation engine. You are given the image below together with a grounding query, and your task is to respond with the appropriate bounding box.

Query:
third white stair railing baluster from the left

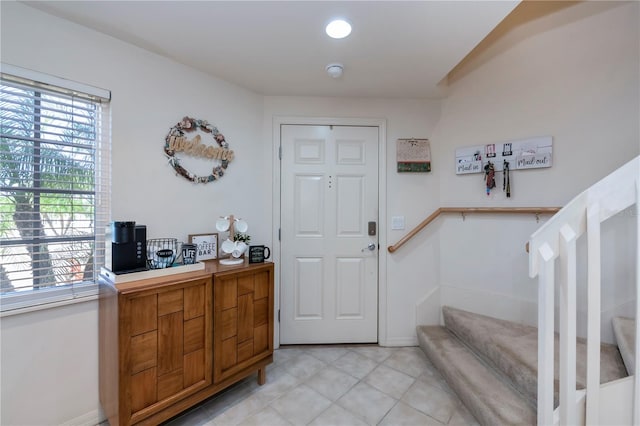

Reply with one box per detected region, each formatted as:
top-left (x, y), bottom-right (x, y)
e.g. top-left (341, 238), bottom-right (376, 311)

top-left (586, 202), bottom-right (601, 424)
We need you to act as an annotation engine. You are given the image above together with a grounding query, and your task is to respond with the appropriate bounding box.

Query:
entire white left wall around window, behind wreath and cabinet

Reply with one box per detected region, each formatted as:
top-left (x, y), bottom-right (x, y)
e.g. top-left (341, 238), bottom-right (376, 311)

top-left (0, 1), bottom-right (264, 425)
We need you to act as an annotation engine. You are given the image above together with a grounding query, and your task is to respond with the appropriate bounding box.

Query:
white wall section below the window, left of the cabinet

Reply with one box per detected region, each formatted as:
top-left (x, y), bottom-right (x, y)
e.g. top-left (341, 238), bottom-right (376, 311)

top-left (0, 300), bottom-right (99, 426)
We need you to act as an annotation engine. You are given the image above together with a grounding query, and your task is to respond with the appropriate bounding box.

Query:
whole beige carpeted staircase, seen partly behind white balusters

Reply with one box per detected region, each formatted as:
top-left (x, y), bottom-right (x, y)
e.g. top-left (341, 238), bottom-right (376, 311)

top-left (417, 306), bottom-right (633, 425)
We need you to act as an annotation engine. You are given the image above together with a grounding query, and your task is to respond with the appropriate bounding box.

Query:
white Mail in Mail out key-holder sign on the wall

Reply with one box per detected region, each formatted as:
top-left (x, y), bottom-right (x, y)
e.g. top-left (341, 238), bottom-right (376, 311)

top-left (456, 136), bottom-right (553, 175)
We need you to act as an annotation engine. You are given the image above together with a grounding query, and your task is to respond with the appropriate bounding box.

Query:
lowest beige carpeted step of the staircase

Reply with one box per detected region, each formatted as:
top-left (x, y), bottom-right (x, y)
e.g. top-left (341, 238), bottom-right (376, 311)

top-left (417, 326), bottom-right (536, 425)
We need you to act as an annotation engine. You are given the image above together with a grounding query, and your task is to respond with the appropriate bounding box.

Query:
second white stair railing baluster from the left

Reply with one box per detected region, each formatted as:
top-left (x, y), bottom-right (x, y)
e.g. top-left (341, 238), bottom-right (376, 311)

top-left (559, 225), bottom-right (577, 425)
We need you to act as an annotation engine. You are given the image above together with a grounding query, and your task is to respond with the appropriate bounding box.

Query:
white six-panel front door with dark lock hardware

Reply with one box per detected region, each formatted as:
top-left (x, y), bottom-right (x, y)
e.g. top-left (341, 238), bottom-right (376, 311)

top-left (280, 125), bottom-right (379, 344)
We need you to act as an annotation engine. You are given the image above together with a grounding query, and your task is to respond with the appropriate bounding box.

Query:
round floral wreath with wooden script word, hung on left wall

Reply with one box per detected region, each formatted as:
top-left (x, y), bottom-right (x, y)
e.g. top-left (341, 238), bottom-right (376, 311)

top-left (164, 117), bottom-right (234, 183)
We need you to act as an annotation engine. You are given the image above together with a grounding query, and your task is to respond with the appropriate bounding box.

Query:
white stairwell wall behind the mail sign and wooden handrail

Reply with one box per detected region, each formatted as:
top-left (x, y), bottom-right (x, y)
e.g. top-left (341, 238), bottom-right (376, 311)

top-left (433, 2), bottom-right (640, 332)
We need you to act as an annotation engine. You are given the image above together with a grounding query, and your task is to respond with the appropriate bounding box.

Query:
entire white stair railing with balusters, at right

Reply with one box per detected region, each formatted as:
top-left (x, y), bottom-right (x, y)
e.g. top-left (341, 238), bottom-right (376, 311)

top-left (529, 157), bottom-right (640, 425)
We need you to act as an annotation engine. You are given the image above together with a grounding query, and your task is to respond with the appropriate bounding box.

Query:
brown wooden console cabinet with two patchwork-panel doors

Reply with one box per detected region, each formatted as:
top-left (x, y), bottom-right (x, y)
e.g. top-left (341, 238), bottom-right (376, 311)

top-left (99, 261), bottom-right (274, 426)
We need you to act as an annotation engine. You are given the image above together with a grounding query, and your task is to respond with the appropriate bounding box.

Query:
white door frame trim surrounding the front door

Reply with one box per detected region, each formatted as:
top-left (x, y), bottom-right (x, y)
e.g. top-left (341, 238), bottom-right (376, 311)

top-left (271, 116), bottom-right (387, 348)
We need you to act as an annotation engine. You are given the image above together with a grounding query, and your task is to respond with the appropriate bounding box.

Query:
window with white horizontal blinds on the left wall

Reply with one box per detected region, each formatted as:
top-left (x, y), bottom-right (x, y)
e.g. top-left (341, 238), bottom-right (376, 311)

top-left (0, 65), bottom-right (110, 311)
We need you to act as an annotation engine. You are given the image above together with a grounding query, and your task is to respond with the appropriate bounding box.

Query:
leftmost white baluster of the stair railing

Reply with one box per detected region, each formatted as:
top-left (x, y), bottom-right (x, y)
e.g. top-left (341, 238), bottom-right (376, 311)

top-left (538, 243), bottom-right (555, 425)
